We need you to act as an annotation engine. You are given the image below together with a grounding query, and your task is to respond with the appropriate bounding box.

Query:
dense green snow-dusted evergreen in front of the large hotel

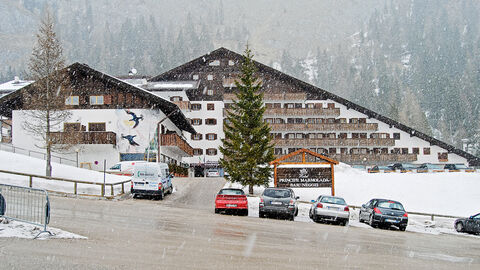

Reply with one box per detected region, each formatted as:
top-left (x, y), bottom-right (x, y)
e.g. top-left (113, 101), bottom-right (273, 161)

top-left (220, 45), bottom-right (274, 194)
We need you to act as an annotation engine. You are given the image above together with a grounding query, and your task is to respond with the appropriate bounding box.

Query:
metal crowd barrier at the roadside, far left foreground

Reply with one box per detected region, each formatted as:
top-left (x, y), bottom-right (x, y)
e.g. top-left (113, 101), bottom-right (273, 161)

top-left (0, 184), bottom-right (52, 239)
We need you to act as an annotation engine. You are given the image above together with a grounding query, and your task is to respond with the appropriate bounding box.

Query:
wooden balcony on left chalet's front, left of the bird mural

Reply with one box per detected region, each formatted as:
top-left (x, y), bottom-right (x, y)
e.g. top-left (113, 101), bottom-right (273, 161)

top-left (50, 131), bottom-right (117, 145)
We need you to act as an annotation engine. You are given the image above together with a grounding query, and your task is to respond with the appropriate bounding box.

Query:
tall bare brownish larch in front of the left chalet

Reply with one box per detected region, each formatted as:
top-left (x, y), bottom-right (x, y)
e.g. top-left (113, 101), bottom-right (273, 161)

top-left (23, 9), bottom-right (71, 176)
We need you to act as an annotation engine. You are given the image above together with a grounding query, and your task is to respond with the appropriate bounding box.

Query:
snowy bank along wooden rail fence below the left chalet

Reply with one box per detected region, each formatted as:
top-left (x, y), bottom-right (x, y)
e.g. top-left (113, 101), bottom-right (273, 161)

top-left (0, 151), bottom-right (130, 195)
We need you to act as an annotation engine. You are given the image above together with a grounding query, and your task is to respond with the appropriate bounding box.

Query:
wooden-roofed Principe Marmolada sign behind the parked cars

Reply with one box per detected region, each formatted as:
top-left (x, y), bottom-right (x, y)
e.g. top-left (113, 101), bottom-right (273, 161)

top-left (270, 149), bottom-right (338, 195)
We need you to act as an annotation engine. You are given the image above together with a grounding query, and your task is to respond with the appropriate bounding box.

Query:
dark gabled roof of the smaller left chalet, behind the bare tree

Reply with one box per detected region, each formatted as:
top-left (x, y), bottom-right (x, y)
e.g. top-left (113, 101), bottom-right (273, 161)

top-left (0, 63), bottom-right (196, 133)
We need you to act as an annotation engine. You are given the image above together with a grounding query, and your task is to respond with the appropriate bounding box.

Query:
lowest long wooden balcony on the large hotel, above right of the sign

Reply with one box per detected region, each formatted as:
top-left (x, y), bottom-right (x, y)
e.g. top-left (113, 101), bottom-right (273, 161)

top-left (327, 154), bottom-right (417, 165)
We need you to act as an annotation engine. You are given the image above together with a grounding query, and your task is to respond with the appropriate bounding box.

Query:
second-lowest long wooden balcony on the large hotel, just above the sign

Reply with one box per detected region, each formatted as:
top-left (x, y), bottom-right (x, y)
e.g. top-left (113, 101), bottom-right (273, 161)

top-left (273, 138), bottom-right (395, 148)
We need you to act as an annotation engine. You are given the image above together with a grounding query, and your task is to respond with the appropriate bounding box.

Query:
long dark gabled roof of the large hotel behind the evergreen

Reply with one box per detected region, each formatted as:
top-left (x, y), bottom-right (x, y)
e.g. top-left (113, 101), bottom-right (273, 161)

top-left (149, 47), bottom-right (480, 166)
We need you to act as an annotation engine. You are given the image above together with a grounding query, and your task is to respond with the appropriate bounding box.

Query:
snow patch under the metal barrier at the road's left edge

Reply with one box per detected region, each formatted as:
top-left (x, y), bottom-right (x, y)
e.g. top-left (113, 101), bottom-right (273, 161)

top-left (0, 219), bottom-right (87, 239)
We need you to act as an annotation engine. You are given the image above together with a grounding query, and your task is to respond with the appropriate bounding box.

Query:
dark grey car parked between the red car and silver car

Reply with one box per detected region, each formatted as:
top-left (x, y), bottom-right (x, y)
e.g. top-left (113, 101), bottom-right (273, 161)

top-left (258, 188), bottom-right (299, 220)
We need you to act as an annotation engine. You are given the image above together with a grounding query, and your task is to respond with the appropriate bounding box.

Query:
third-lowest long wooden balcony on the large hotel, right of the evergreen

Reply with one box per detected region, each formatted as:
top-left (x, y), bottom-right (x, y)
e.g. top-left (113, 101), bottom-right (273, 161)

top-left (270, 123), bottom-right (378, 132)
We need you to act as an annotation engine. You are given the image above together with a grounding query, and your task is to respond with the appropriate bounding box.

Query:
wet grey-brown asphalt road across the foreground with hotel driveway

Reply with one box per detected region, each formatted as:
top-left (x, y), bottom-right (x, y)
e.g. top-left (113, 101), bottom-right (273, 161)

top-left (0, 178), bottom-right (480, 269)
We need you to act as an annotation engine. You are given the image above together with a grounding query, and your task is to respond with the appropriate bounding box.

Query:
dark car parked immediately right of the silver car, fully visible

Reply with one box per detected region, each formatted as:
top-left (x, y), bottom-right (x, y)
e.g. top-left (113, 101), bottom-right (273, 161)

top-left (358, 199), bottom-right (408, 231)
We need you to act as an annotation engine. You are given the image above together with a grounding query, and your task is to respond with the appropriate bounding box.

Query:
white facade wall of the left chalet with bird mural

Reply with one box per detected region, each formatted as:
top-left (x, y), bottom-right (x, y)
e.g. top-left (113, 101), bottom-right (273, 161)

top-left (12, 109), bottom-right (182, 170)
